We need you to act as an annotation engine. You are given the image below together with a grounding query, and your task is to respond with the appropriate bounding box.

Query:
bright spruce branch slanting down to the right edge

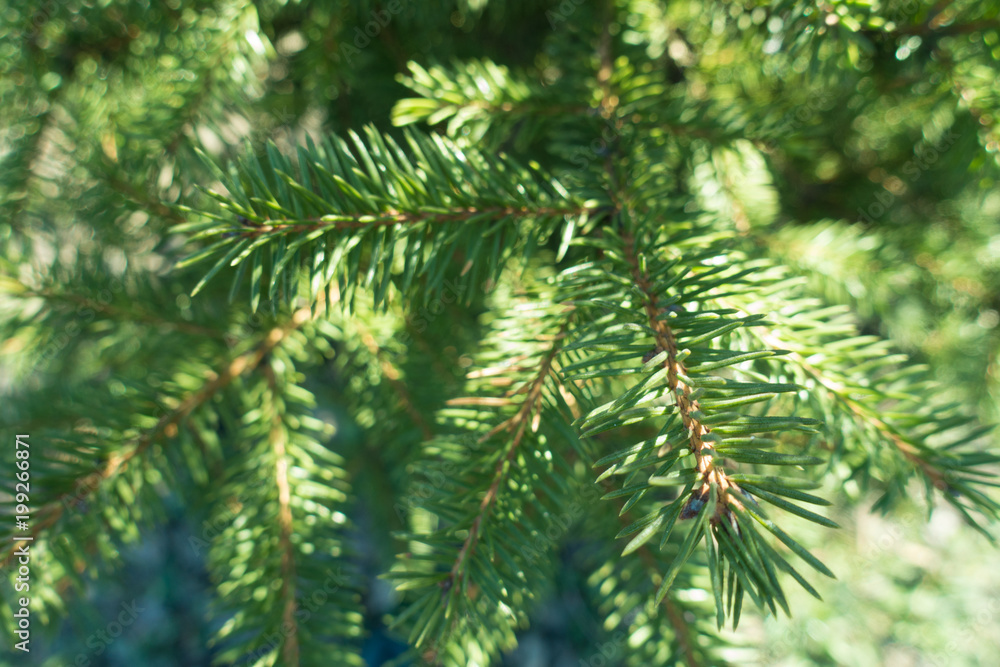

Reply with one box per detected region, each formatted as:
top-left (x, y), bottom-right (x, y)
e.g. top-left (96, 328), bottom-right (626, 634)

top-left (719, 287), bottom-right (1000, 541)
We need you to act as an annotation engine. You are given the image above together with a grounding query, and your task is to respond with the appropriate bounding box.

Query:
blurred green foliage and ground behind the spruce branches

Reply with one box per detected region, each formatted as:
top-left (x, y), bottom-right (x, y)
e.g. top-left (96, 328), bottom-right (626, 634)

top-left (0, 0), bottom-right (1000, 667)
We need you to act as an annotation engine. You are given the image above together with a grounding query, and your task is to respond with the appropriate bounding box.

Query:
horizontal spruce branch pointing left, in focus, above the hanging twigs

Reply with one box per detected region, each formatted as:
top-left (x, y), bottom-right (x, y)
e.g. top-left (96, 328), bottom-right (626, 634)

top-left (179, 128), bottom-right (594, 310)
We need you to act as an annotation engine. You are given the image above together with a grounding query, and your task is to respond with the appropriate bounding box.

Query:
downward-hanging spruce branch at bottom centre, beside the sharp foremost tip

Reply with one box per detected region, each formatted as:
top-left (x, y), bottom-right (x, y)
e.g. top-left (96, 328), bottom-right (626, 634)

top-left (387, 283), bottom-right (573, 661)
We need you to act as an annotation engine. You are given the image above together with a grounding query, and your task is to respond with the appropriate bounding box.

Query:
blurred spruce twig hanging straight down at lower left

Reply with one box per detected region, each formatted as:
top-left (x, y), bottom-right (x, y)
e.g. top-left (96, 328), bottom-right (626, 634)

top-left (209, 346), bottom-right (363, 666)
